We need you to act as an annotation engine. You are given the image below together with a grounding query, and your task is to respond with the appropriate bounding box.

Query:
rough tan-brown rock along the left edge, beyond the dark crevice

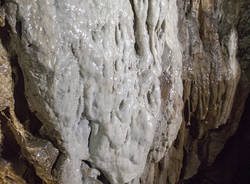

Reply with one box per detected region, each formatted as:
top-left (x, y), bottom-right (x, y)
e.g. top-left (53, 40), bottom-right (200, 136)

top-left (0, 25), bottom-right (58, 184)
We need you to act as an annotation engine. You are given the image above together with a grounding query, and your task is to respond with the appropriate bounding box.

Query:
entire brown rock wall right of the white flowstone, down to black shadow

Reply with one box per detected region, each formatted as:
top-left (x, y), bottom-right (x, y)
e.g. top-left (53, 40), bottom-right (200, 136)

top-left (141, 0), bottom-right (250, 184)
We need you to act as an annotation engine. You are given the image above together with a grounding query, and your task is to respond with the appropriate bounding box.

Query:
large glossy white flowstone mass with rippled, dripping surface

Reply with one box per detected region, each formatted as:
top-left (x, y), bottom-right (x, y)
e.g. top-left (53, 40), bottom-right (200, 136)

top-left (3, 0), bottom-right (182, 184)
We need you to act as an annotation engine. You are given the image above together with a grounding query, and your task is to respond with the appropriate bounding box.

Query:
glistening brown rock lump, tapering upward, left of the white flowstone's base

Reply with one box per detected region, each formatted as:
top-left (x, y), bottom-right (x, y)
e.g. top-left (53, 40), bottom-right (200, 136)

top-left (9, 109), bottom-right (58, 184)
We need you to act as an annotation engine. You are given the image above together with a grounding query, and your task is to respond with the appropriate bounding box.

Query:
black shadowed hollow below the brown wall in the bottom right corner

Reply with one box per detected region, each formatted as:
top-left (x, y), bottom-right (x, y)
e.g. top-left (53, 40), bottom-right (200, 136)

top-left (184, 95), bottom-right (250, 184)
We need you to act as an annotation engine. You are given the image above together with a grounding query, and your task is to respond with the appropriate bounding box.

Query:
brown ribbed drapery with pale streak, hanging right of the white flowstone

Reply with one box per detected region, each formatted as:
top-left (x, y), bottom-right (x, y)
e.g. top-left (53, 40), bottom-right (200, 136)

top-left (178, 1), bottom-right (240, 179)
